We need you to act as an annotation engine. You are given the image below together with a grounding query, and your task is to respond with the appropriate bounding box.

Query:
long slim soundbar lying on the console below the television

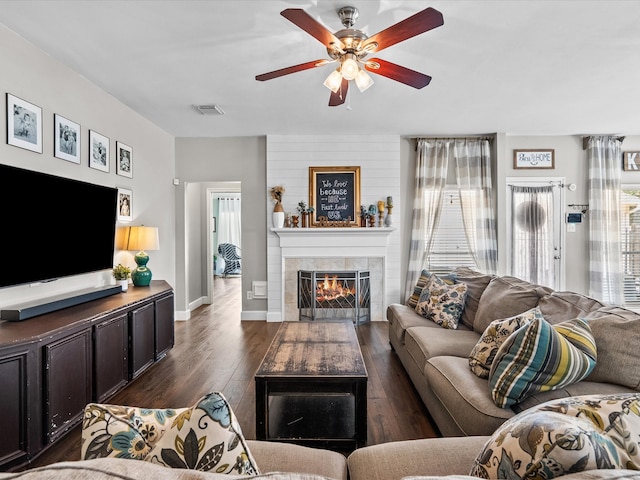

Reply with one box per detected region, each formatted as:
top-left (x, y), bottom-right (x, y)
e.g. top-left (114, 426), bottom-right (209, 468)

top-left (0, 285), bottom-right (122, 322)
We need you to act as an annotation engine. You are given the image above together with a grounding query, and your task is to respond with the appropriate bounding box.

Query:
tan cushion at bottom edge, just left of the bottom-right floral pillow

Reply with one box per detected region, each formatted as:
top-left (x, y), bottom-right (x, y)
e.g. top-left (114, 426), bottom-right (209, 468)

top-left (344, 437), bottom-right (489, 480)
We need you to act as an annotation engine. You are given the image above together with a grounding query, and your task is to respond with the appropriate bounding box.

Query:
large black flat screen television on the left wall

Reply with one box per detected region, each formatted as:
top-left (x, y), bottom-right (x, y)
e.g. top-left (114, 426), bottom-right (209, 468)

top-left (0, 165), bottom-right (118, 288)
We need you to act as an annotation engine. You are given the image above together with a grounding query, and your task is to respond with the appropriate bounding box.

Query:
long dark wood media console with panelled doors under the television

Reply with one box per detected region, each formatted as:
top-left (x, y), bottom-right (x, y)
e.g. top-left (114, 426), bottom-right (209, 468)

top-left (0, 280), bottom-right (174, 471)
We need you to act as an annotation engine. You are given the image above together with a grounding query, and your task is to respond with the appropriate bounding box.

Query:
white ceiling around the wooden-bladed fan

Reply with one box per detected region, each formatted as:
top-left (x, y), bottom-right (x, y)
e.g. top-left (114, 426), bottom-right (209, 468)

top-left (0, 0), bottom-right (640, 137)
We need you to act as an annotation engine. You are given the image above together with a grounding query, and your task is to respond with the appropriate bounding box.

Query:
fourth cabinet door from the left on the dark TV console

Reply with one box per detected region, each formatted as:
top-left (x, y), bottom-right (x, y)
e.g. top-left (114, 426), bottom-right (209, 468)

top-left (129, 303), bottom-right (155, 378)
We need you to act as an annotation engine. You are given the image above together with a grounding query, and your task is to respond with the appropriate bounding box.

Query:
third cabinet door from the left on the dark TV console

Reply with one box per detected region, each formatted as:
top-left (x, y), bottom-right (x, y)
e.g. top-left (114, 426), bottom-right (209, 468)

top-left (93, 313), bottom-right (129, 403)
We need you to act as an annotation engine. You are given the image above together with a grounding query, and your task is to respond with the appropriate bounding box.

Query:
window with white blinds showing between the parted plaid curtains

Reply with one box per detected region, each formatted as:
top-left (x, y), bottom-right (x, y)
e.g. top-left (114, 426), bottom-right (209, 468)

top-left (427, 185), bottom-right (477, 273)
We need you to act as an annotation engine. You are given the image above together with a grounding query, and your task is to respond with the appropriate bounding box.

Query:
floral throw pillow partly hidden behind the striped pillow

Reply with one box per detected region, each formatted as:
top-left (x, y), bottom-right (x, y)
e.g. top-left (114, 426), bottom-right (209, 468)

top-left (469, 307), bottom-right (542, 378)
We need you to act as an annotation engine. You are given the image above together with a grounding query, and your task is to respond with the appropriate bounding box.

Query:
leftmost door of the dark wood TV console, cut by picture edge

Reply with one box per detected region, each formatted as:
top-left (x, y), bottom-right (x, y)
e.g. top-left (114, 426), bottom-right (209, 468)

top-left (0, 351), bottom-right (35, 467)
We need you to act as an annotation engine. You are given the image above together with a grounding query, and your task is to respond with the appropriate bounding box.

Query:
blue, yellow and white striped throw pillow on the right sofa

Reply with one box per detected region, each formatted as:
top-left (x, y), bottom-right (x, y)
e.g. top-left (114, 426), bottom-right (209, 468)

top-left (489, 318), bottom-right (597, 408)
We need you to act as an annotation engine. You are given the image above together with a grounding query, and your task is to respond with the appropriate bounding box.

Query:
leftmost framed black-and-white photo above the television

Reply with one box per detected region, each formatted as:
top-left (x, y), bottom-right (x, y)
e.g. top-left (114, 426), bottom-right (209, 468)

top-left (7, 93), bottom-right (42, 153)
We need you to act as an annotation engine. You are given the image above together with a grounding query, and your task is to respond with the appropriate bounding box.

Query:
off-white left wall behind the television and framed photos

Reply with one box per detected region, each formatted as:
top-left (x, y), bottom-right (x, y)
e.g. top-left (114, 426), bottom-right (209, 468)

top-left (0, 25), bottom-right (175, 306)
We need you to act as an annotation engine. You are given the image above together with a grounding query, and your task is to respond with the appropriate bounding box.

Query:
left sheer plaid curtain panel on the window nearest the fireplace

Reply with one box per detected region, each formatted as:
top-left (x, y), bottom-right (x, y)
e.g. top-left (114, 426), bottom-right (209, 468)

top-left (405, 139), bottom-right (453, 298)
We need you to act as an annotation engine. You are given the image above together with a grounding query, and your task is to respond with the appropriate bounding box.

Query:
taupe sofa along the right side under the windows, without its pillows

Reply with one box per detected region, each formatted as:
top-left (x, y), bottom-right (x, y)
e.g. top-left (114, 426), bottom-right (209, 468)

top-left (387, 268), bottom-right (640, 436)
